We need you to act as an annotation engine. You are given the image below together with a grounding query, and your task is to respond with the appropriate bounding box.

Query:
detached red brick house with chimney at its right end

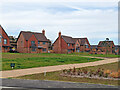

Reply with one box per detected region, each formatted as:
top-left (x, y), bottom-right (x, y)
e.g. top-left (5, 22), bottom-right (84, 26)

top-left (17, 30), bottom-right (49, 53)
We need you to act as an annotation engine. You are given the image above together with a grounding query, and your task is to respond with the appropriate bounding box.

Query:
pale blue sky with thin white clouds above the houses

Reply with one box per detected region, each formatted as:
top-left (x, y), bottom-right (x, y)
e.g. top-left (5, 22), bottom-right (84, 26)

top-left (0, 0), bottom-right (118, 44)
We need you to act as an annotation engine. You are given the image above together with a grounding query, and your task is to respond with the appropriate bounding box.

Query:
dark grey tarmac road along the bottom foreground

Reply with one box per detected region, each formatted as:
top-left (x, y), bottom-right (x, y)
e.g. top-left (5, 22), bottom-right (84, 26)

top-left (2, 78), bottom-right (118, 90)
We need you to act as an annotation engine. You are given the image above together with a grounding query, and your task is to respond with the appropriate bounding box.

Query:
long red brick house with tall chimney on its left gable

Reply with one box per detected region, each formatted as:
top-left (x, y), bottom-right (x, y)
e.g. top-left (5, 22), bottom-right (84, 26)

top-left (53, 32), bottom-right (90, 53)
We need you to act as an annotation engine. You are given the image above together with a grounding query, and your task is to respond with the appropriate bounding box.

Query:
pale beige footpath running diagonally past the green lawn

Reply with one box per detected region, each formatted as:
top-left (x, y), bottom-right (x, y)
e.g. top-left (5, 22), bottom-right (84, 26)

top-left (0, 58), bottom-right (119, 78)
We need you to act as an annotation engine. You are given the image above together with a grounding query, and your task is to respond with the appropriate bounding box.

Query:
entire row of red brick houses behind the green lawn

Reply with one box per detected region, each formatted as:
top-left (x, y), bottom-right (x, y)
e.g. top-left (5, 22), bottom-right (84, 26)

top-left (0, 25), bottom-right (120, 54)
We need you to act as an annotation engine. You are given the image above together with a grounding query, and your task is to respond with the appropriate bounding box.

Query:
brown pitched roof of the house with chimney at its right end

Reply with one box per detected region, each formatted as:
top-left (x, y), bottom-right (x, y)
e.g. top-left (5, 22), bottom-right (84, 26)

top-left (21, 31), bottom-right (48, 41)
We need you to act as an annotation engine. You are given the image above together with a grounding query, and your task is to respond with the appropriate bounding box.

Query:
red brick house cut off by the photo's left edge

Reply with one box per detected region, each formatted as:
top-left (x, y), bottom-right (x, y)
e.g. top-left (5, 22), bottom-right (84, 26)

top-left (0, 25), bottom-right (10, 52)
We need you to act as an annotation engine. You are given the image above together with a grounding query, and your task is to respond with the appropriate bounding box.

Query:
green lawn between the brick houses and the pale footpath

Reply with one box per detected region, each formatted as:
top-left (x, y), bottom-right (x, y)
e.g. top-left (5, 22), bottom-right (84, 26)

top-left (2, 53), bottom-right (103, 70)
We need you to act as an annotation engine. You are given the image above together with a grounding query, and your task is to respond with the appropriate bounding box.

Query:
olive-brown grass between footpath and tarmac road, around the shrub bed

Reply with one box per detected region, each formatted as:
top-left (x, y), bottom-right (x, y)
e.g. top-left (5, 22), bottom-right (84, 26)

top-left (16, 62), bottom-right (120, 86)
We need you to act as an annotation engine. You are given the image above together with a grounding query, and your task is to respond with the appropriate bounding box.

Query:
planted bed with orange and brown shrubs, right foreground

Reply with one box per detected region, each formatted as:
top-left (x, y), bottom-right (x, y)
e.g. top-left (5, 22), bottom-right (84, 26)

top-left (60, 67), bottom-right (120, 80)
